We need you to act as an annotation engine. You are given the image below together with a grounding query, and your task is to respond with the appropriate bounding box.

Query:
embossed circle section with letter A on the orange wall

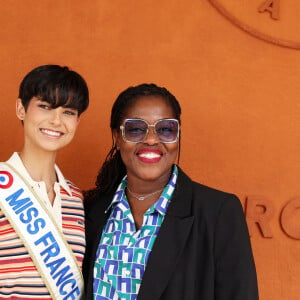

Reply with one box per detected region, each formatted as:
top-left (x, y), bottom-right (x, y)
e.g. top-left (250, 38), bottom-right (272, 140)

top-left (208, 0), bottom-right (300, 49)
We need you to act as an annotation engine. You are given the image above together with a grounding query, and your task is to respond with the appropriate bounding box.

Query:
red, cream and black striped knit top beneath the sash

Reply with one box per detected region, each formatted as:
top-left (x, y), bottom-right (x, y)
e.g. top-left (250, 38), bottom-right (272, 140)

top-left (0, 154), bottom-right (85, 300)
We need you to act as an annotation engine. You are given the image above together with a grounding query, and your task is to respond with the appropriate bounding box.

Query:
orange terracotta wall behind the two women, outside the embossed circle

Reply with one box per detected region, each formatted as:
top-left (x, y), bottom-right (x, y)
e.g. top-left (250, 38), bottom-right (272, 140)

top-left (0, 0), bottom-right (300, 300)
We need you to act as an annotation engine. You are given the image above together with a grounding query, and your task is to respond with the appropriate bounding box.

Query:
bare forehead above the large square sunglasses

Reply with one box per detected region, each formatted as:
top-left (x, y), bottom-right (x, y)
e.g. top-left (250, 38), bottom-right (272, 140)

top-left (124, 96), bottom-right (175, 122)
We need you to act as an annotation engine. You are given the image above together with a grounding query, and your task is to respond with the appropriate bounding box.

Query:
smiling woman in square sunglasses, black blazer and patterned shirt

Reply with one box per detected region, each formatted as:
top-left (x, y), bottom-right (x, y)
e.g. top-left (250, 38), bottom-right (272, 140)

top-left (83, 84), bottom-right (258, 300)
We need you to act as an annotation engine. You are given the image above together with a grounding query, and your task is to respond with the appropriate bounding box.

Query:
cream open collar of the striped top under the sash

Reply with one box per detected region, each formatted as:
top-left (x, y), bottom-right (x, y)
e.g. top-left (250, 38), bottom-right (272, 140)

top-left (7, 152), bottom-right (72, 196)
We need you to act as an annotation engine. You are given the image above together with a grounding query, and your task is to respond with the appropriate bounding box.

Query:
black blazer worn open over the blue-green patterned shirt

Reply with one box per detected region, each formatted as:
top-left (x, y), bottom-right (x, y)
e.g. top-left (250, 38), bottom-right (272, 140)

top-left (83, 169), bottom-right (258, 300)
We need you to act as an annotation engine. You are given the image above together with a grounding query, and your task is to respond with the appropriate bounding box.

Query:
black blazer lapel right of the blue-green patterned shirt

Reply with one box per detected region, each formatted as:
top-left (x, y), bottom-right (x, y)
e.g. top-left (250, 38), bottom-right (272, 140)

top-left (138, 169), bottom-right (194, 300)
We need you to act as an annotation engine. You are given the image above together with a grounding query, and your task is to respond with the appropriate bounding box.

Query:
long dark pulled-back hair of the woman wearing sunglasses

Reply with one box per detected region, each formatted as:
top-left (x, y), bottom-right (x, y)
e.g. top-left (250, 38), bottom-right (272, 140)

top-left (85, 83), bottom-right (181, 199)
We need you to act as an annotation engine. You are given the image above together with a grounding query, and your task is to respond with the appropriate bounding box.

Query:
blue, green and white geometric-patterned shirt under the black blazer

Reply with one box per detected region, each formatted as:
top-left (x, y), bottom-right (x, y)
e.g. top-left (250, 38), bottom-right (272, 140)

top-left (94, 165), bottom-right (178, 300)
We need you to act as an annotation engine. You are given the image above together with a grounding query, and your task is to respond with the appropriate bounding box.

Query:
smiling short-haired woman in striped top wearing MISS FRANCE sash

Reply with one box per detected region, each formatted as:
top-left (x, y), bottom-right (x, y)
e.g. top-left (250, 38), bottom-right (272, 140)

top-left (0, 65), bottom-right (89, 300)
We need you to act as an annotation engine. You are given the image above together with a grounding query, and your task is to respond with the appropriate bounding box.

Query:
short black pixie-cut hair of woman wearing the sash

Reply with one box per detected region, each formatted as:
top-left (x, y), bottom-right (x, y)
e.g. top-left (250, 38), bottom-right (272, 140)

top-left (19, 65), bottom-right (89, 115)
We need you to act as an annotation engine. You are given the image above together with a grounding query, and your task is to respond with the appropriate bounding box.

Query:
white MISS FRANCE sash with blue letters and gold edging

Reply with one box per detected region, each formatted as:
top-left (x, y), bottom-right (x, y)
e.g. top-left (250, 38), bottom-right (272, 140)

top-left (0, 163), bottom-right (83, 300)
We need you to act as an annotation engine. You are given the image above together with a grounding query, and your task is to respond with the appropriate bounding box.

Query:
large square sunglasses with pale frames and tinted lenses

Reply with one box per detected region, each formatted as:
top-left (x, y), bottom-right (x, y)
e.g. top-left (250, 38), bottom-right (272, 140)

top-left (120, 119), bottom-right (179, 143)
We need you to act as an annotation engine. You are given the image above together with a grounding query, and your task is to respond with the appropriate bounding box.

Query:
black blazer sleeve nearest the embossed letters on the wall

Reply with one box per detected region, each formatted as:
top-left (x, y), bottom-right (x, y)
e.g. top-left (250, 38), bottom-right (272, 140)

top-left (214, 195), bottom-right (258, 300)
